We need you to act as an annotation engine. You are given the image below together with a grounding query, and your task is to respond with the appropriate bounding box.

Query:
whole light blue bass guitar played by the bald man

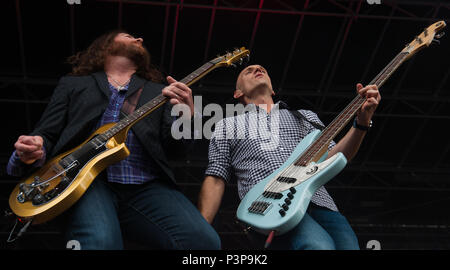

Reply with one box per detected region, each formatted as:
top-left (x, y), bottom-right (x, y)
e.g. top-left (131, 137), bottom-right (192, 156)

top-left (237, 21), bottom-right (445, 235)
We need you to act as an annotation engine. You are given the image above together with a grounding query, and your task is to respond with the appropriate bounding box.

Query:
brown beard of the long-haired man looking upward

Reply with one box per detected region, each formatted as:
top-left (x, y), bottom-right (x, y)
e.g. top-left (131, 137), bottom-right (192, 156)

top-left (107, 42), bottom-right (150, 70)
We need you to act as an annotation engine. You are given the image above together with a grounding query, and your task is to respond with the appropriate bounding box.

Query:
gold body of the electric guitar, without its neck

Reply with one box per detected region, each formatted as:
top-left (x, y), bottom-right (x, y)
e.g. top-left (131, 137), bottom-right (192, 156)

top-left (9, 123), bottom-right (130, 224)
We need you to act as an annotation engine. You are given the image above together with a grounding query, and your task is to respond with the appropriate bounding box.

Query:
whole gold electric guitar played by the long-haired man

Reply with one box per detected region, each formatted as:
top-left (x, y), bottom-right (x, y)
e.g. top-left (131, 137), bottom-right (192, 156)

top-left (9, 47), bottom-right (250, 224)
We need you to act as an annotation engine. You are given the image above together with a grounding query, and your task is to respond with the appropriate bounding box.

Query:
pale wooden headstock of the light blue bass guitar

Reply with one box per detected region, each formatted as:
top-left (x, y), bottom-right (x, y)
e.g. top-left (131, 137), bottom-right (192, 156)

top-left (402, 21), bottom-right (446, 58)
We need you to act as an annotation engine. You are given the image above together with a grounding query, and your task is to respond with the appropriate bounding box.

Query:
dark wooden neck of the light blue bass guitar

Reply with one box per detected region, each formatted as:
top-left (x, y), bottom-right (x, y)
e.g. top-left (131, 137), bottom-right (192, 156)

top-left (295, 51), bottom-right (408, 166)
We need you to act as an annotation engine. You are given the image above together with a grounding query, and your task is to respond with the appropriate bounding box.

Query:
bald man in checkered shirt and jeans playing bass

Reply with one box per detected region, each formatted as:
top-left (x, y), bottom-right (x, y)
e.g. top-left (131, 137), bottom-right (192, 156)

top-left (198, 65), bottom-right (381, 250)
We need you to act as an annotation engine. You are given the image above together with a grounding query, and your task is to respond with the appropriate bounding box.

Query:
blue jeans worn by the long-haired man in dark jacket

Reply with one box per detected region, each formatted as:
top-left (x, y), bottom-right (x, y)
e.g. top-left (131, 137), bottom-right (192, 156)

top-left (66, 179), bottom-right (221, 250)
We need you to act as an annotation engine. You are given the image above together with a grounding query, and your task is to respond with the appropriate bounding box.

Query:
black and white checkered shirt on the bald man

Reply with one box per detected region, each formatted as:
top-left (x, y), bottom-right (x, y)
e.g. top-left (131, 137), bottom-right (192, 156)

top-left (205, 101), bottom-right (338, 211)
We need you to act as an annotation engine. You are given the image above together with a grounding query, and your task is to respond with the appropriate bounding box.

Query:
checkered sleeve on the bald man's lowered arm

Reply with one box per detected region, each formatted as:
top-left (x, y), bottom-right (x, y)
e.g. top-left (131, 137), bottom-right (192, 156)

top-left (205, 120), bottom-right (232, 183)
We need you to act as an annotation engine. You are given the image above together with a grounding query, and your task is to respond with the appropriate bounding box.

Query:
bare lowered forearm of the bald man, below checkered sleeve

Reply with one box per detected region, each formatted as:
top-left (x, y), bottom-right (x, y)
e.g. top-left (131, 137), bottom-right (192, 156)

top-left (198, 176), bottom-right (225, 223)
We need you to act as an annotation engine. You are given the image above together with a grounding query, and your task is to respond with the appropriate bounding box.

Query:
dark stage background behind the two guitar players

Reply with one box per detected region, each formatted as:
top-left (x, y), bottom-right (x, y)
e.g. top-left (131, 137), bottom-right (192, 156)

top-left (0, 0), bottom-right (450, 250)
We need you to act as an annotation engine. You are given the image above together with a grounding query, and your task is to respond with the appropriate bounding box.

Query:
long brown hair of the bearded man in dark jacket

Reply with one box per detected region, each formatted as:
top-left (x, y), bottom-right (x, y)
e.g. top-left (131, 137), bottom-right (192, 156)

top-left (67, 30), bottom-right (165, 82)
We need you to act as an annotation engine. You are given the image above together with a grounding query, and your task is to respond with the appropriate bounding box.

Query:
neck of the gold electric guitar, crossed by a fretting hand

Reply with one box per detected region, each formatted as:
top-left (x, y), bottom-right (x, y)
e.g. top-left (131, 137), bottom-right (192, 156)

top-left (103, 62), bottom-right (216, 140)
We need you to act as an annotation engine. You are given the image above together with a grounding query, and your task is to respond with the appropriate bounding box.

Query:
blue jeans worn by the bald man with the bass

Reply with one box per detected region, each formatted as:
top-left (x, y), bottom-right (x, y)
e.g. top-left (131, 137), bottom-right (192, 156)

top-left (249, 206), bottom-right (359, 250)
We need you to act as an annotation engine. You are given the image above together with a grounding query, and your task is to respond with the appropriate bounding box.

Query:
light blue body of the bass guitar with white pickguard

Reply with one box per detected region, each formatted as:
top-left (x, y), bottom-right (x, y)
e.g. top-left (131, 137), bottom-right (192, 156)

top-left (237, 130), bottom-right (347, 235)
